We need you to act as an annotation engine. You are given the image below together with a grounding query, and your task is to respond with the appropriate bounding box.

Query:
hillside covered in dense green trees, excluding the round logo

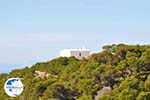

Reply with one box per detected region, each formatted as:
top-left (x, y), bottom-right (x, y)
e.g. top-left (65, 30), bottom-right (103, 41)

top-left (0, 44), bottom-right (150, 100)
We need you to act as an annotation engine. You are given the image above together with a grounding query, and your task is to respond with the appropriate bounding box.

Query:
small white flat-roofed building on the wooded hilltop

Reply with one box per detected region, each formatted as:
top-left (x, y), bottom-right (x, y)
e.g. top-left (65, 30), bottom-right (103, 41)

top-left (60, 49), bottom-right (90, 59)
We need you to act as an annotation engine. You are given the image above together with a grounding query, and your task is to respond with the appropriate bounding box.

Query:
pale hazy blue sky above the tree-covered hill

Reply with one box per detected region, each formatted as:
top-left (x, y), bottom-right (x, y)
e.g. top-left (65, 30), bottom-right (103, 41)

top-left (0, 0), bottom-right (150, 73)
